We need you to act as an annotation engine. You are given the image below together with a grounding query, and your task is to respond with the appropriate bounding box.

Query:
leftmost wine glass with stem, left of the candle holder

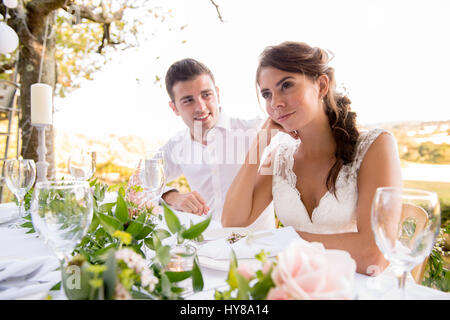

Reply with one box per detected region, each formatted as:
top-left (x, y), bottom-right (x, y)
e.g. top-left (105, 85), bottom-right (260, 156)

top-left (5, 159), bottom-right (36, 227)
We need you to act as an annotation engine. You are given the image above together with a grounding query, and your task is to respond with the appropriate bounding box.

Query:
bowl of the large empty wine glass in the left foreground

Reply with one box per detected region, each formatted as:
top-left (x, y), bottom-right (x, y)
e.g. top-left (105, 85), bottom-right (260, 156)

top-left (31, 180), bottom-right (93, 261)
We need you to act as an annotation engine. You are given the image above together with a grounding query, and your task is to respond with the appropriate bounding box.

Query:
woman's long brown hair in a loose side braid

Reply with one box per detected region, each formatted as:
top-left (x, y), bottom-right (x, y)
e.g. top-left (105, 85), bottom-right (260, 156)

top-left (256, 42), bottom-right (359, 195)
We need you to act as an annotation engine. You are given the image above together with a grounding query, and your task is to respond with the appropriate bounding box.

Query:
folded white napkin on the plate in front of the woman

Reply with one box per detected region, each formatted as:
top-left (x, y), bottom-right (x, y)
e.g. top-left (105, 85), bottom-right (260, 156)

top-left (197, 226), bottom-right (301, 260)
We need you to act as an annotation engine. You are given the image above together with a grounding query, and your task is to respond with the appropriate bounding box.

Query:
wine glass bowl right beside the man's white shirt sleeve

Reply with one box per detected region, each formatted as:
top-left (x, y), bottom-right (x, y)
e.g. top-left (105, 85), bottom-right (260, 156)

top-left (143, 151), bottom-right (165, 200)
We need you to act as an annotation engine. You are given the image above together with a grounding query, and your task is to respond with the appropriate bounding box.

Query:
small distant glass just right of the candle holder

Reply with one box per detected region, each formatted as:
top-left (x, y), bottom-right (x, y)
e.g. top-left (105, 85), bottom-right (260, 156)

top-left (68, 150), bottom-right (97, 180)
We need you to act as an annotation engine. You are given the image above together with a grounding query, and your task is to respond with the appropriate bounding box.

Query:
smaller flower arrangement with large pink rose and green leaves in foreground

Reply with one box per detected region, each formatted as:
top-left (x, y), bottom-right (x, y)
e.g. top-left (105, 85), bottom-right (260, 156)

top-left (215, 240), bottom-right (356, 300)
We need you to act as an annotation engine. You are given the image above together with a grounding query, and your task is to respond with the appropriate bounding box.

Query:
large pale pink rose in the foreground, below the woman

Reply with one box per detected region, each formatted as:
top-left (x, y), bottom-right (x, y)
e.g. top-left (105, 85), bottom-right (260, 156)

top-left (268, 240), bottom-right (356, 300)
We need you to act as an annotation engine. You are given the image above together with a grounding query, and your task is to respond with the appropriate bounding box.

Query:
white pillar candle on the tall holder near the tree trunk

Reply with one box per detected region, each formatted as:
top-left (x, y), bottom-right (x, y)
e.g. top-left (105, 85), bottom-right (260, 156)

top-left (31, 83), bottom-right (53, 125)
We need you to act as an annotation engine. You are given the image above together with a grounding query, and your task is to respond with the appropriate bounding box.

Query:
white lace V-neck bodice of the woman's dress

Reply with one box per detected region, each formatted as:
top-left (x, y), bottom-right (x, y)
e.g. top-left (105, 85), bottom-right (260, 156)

top-left (269, 129), bottom-right (386, 234)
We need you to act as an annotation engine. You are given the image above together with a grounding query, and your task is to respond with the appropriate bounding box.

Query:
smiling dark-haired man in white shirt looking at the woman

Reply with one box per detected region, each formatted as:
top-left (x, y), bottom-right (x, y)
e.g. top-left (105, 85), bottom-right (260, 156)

top-left (155, 59), bottom-right (275, 230)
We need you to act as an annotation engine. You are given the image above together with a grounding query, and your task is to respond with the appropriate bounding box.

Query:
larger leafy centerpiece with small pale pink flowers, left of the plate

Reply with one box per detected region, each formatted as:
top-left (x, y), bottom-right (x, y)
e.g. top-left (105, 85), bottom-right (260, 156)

top-left (24, 180), bottom-right (210, 300)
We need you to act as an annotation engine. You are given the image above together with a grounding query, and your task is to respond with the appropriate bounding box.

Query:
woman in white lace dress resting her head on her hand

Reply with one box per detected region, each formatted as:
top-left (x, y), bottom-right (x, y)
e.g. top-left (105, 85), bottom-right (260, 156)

top-left (222, 42), bottom-right (402, 274)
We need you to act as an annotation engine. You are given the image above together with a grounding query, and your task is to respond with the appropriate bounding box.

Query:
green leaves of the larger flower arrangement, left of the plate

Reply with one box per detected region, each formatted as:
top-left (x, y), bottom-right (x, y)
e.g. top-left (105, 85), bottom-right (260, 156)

top-left (25, 179), bottom-right (211, 299)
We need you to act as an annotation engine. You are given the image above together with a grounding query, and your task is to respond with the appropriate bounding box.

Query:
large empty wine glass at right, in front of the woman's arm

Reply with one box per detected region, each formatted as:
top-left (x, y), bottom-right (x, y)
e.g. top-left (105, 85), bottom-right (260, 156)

top-left (371, 187), bottom-right (441, 298)
